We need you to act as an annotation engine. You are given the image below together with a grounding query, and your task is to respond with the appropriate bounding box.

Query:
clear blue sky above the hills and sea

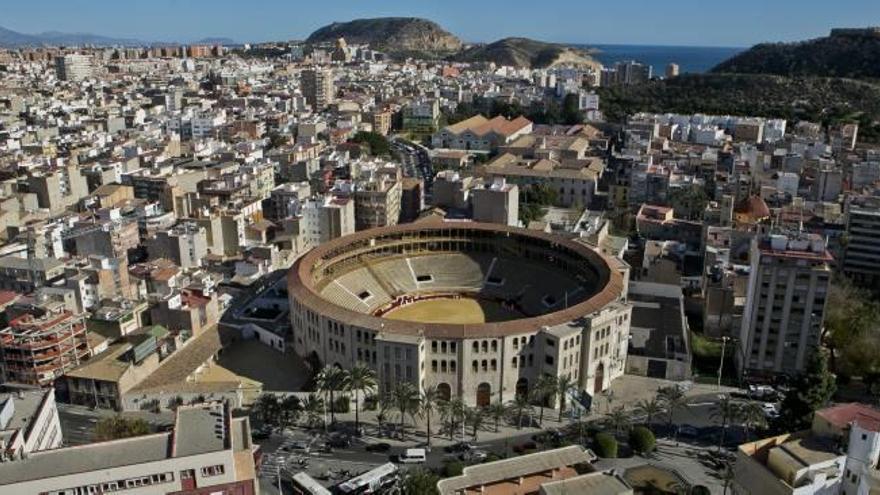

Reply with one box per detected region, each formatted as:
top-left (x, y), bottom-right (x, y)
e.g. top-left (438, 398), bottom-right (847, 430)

top-left (0, 0), bottom-right (880, 46)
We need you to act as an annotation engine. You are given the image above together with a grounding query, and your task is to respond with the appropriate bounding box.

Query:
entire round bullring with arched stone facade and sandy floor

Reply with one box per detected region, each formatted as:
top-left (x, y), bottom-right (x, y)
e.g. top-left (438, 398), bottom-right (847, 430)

top-left (288, 220), bottom-right (631, 406)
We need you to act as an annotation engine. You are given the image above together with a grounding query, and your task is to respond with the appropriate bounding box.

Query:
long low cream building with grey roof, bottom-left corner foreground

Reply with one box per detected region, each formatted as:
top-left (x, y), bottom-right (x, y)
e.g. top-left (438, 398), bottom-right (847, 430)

top-left (0, 402), bottom-right (259, 495)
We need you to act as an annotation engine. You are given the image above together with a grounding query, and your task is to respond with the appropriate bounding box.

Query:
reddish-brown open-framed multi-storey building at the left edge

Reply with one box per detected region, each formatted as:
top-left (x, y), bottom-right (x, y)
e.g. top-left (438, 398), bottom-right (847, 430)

top-left (0, 310), bottom-right (91, 386)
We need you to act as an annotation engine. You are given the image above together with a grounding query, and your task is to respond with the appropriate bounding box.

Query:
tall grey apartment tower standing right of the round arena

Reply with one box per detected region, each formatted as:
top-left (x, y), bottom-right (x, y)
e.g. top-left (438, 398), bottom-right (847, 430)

top-left (736, 233), bottom-right (833, 375)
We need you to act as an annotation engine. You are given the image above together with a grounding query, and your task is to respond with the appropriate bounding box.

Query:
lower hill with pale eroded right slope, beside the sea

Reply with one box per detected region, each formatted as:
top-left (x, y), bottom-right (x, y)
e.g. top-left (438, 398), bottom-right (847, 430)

top-left (453, 38), bottom-right (599, 68)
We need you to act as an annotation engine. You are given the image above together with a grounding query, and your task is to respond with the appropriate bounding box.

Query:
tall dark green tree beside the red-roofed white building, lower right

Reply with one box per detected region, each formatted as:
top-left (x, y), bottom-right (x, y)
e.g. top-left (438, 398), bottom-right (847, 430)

top-left (779, 349), bottom-right (837, 431)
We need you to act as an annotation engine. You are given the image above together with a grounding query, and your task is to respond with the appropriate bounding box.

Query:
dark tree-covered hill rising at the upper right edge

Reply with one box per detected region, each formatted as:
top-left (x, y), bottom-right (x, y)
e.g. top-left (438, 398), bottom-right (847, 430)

top-left (712, 28), bottom-right (880, 79)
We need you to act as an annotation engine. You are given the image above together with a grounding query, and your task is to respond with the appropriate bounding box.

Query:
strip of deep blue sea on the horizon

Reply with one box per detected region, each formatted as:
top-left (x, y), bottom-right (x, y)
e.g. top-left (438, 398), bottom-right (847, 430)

top-left (575, 44), bottom-right (745, 76)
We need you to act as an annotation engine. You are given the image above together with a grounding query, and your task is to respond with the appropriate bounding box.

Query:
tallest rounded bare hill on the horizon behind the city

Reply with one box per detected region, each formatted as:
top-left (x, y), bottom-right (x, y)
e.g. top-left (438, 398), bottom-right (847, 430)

top-left (306, 17), bottom-right (462, 54)
